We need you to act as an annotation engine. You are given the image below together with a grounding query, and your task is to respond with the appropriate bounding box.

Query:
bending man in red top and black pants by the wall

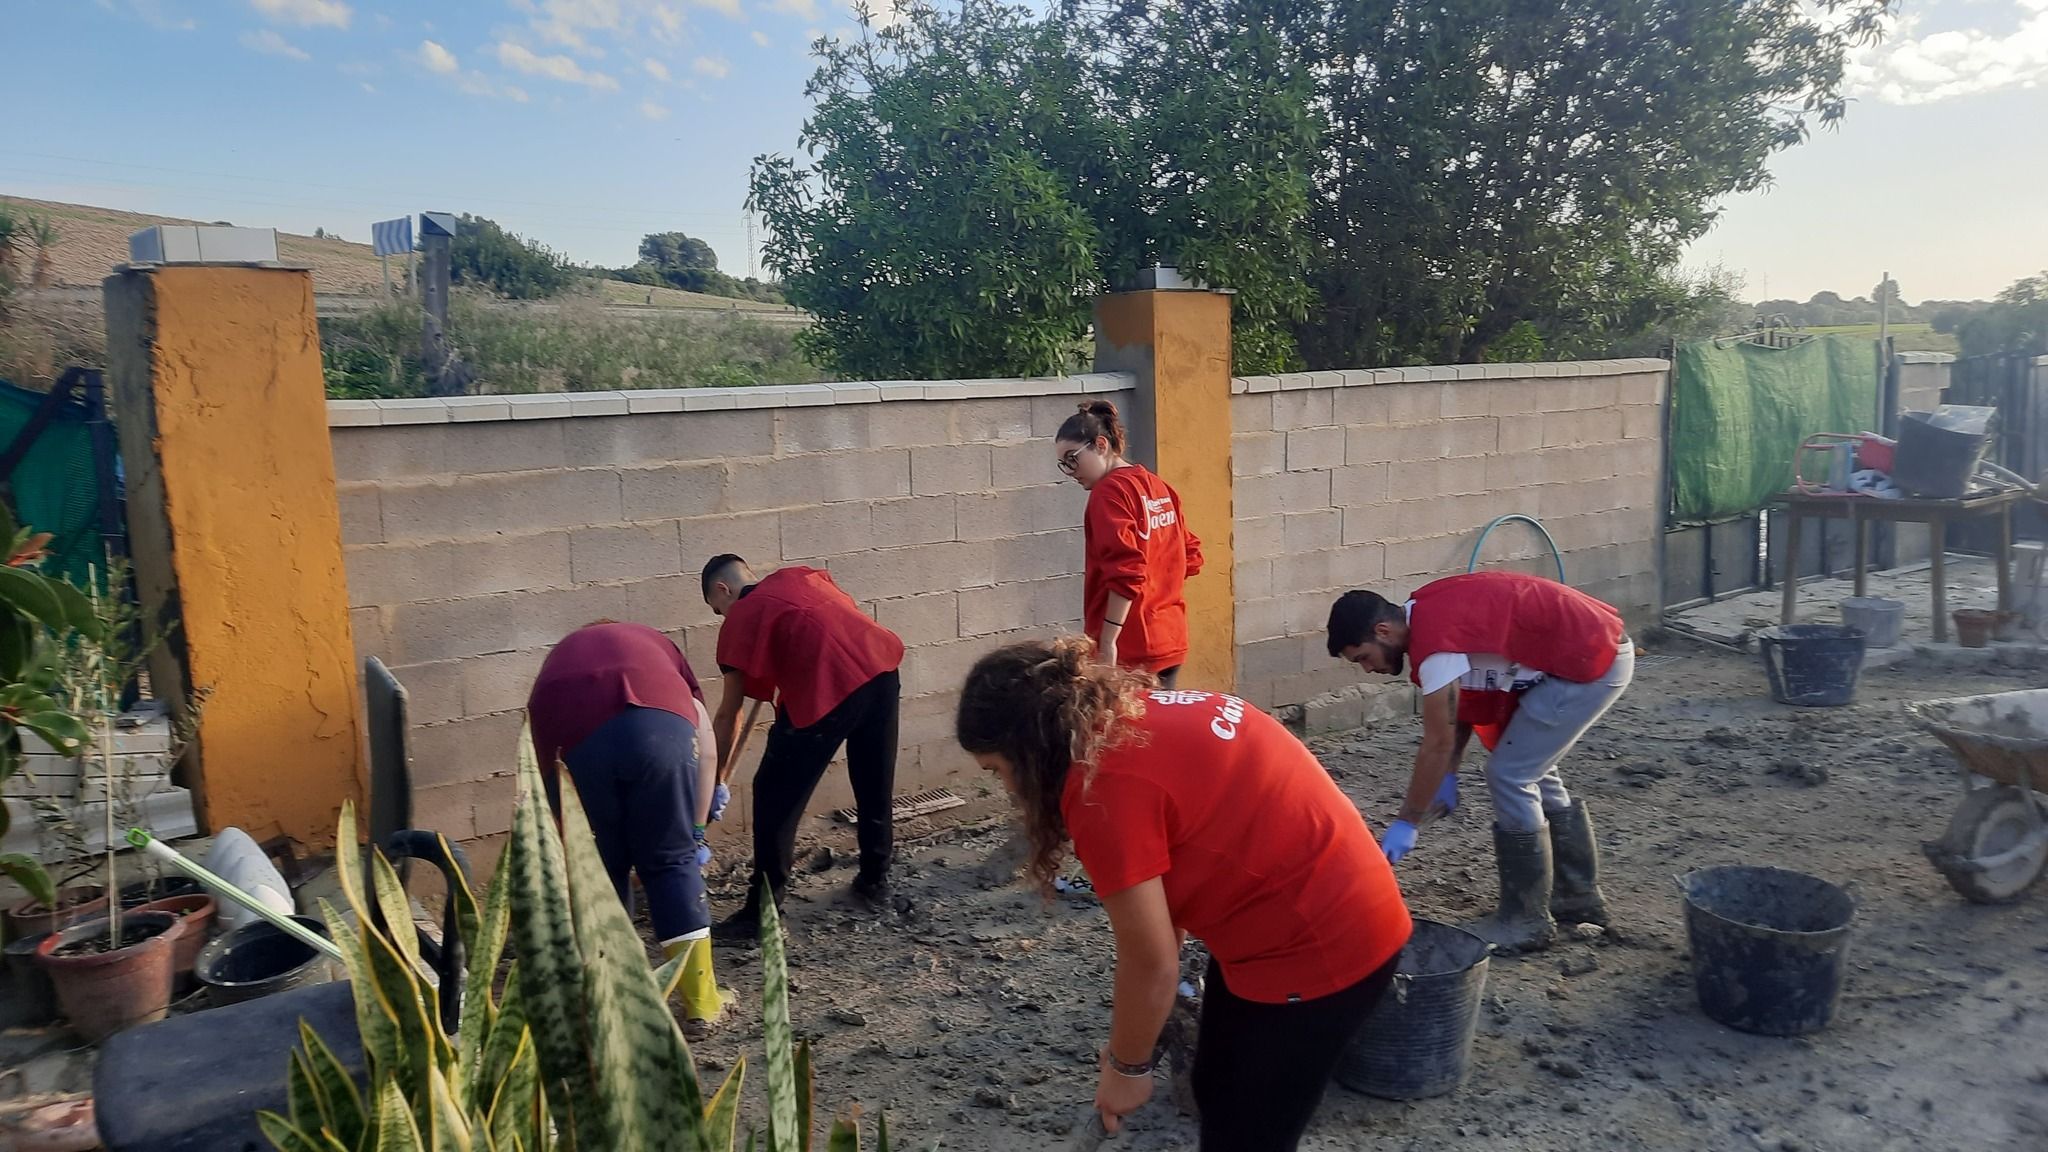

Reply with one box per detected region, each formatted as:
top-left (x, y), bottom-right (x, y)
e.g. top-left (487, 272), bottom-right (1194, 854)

top-left (702, 553), bottom-right (903, 941)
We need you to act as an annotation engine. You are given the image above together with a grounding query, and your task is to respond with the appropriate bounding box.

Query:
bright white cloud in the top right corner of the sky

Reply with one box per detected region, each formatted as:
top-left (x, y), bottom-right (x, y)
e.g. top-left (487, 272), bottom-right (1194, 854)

top-left (1845, 0), bottom-right (2048, 105)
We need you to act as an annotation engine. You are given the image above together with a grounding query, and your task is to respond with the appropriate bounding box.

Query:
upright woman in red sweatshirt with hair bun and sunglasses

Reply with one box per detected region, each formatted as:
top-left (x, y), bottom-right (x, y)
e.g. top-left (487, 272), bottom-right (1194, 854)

top-left (1053, 400), bottom-right (1202, 689)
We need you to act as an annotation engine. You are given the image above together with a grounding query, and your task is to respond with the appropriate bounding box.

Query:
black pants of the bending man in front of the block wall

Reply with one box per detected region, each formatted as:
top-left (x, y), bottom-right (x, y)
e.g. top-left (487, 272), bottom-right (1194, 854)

top-left (748, 672), bottom-right (903, 904)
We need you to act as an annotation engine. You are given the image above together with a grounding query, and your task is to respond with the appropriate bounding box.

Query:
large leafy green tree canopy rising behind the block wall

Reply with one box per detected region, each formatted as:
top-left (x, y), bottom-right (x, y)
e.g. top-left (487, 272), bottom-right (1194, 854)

top-left (750, 0), bottom-right (1888, 375)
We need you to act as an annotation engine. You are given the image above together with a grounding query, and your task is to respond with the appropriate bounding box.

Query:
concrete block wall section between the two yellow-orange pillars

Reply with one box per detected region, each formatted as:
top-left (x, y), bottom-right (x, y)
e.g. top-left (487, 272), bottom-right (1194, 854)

top-left (330, 373), bottom-right (1135, 838)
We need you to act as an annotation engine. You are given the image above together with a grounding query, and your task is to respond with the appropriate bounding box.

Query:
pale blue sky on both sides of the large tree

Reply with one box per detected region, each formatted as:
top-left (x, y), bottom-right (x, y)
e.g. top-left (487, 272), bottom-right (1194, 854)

top-left (0, 0), bottom-right (2048, 299)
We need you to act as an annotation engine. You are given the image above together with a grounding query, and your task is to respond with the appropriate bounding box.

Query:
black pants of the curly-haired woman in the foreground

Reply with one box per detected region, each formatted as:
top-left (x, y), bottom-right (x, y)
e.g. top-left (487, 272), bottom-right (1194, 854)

top-left (1194, 957), bottom-right (1399, 1152)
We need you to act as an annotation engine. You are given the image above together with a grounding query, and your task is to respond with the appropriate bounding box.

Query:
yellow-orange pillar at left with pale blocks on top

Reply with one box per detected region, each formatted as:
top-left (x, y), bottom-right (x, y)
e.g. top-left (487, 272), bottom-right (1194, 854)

top-left (104, 264), bottom-right (365, 847)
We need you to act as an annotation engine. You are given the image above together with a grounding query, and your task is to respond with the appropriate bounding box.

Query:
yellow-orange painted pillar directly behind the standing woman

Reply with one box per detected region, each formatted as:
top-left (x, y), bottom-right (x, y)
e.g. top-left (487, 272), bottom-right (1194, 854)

top-left (1096, 289), bottom-right (1237, 691)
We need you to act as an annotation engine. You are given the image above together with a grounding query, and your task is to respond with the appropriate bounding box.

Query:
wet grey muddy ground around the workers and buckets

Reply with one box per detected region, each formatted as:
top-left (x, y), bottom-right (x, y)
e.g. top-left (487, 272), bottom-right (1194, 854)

top-left (679, 646), bottom-right (2048, 1152)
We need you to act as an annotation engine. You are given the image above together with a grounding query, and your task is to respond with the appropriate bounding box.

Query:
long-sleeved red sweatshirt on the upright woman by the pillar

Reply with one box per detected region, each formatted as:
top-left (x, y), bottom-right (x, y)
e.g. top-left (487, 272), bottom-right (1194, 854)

top-left (1081, 463), bottom-right (1202, 672)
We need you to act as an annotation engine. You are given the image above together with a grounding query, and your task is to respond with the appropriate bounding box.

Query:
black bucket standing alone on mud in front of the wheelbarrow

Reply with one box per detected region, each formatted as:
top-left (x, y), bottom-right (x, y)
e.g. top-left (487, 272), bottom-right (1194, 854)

top-left (1677, 865), bottom-right (1855, 1035)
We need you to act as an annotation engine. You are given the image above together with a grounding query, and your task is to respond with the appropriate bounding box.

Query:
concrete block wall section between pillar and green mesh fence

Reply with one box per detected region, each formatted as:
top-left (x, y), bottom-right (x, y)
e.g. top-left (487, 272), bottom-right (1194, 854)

top-left (1231, 359), bottom-right (1669, 715)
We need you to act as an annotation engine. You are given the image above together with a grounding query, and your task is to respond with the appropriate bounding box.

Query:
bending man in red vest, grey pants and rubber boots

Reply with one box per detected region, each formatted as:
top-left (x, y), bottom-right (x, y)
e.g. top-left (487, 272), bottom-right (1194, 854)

top-left (1329, 572), bottom-right (1636, 951)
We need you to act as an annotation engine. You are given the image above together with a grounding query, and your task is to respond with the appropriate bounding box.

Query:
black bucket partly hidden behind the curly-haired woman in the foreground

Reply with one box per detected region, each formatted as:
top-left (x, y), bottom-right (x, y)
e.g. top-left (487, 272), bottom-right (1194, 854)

top-left (1337, 920), bottom-right (1493, 1101)
